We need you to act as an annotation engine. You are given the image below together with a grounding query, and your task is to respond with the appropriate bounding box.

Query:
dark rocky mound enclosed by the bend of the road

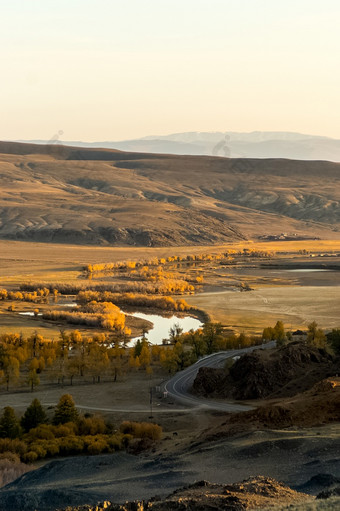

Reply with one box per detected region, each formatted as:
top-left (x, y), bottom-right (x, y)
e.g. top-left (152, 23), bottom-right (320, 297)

top-left (193, 342), bottom-right (340, 400)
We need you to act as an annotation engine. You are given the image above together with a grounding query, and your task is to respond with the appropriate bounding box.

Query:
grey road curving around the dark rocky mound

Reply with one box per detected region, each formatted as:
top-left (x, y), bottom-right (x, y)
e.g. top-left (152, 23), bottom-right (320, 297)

top-left (164, 341), bottom-right (276, 412)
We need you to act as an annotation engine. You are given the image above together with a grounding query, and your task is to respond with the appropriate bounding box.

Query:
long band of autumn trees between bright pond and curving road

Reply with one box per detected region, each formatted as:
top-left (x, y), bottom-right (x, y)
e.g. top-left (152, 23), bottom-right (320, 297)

top-left (0, 323), bottom-right (262, 390)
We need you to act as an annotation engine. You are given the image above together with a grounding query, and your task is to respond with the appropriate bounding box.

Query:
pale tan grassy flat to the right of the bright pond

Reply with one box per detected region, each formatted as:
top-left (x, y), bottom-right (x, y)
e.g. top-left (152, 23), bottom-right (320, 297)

top-left (187, 288), bottom-right (340, 333)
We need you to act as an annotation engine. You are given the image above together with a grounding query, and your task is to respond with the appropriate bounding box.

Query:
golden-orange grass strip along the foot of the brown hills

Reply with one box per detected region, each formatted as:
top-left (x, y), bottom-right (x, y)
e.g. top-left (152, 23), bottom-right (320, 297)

top-left (0, 239), bottom-right (340, 279)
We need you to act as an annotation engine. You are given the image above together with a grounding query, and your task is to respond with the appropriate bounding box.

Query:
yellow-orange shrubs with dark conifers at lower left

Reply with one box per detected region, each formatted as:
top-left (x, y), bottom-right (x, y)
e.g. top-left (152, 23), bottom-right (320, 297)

top-left (0, 394), bottom-right (162, 463)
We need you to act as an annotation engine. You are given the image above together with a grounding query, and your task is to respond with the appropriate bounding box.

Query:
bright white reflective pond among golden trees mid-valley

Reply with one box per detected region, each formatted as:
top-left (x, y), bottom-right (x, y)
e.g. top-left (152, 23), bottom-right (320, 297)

top-left (129, 312), bottom-right (203, 344)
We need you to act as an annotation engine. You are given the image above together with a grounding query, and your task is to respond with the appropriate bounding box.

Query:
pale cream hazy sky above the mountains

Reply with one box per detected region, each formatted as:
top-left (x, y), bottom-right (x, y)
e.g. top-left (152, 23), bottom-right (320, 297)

top-left (0, 0), bottom-right (340, 141)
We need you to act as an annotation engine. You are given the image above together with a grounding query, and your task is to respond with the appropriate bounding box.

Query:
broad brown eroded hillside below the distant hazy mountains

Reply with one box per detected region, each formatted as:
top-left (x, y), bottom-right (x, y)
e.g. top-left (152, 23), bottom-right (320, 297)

top-left (0, 142), bottom-right (340, 246)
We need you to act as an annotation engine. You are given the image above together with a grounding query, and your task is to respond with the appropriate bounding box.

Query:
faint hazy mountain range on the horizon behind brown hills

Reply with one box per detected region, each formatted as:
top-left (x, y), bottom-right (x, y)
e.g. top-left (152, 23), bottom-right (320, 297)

top-left (19, 131), bottom-right (340, 162)
